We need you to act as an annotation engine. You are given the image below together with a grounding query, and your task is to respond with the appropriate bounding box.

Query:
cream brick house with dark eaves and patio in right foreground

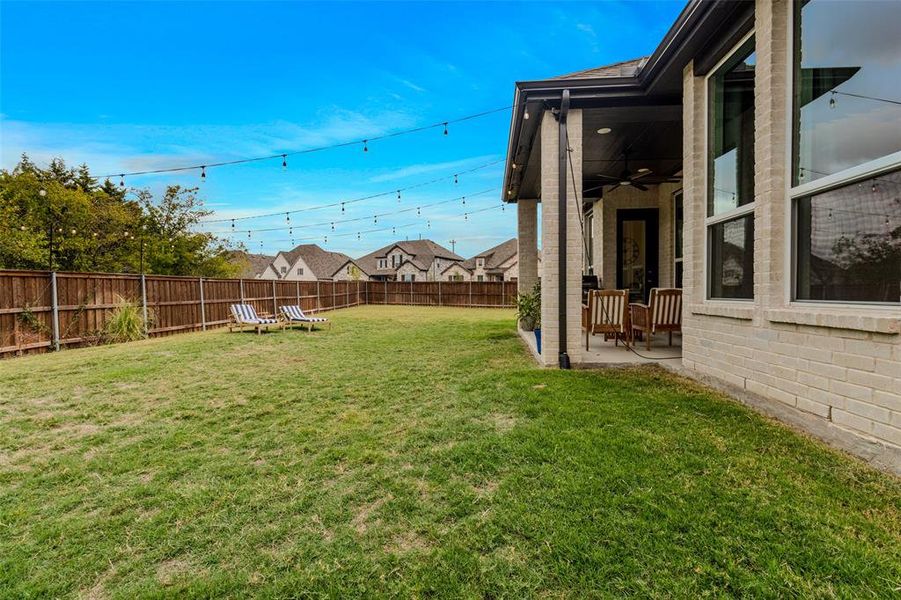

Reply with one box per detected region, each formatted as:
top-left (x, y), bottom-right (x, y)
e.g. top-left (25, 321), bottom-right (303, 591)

top-left (503, 0), bottom-right (901, 472)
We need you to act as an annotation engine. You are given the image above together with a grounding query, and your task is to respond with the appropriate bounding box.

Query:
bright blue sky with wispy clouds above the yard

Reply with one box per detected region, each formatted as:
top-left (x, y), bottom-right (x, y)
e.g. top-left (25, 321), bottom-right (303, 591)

top-left (0, 1), bottom-right (684, 256)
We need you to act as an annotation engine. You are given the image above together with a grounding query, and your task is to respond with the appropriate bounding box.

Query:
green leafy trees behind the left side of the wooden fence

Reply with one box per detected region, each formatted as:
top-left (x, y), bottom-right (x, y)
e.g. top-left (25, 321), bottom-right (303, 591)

top-left (0, 155), bottom-right (237, 277)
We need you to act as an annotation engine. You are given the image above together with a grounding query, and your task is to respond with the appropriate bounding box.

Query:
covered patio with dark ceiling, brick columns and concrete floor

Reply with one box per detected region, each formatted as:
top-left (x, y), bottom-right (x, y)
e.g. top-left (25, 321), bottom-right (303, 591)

top-left (504, 58), bottom-right (683, 368)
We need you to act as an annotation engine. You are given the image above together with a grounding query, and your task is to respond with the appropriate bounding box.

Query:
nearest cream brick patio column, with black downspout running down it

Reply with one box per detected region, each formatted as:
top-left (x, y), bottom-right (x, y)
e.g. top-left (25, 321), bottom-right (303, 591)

top-left (541, 109), bottom-right (583, 366)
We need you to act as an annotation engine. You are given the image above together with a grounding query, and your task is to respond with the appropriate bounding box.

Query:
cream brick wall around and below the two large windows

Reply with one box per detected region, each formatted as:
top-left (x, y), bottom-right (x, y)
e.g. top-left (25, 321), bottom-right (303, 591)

top-left (682, 0), bottom-right (901, 472)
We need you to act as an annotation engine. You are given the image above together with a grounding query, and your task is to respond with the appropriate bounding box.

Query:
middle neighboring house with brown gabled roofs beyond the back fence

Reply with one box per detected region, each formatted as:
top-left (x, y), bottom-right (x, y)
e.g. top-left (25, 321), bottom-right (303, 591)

top-left (357, 240), bottom-right (463, 281)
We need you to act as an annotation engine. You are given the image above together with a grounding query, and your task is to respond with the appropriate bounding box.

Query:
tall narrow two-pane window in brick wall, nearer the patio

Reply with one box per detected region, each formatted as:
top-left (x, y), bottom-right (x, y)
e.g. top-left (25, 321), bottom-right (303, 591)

top-left (706, 37), bottom-right (756, 299)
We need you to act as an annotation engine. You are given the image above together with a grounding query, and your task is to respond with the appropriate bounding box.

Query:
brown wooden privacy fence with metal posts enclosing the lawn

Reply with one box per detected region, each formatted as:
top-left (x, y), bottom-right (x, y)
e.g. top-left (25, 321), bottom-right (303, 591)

top-left (0, 270), bottom-right (516, 357)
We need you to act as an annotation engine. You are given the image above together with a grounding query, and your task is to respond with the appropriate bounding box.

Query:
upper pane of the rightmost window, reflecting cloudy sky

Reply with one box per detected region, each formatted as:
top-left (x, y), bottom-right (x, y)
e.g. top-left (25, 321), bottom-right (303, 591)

top-left (792, 0), bottom-right (901, 185)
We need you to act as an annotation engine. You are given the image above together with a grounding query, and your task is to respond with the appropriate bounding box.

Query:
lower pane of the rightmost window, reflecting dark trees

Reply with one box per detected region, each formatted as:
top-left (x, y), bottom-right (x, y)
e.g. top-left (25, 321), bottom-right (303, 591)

top-left (796, 172), bottom-right (901, 302)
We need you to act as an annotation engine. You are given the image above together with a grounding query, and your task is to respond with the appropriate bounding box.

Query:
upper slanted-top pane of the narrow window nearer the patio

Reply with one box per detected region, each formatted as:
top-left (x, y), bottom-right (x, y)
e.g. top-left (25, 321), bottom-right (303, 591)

top-left (707, 38), bottom-right (755, 216)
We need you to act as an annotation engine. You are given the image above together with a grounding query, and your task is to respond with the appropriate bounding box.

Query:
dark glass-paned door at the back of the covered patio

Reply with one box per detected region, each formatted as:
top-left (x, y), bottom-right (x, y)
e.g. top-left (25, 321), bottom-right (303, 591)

top-left (616, 208), bottom-right (659, 302)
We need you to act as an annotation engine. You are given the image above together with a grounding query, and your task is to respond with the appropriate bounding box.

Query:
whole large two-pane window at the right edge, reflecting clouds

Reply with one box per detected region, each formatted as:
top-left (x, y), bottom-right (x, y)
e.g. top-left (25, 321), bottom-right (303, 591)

top-left (790, 0), bottom-right (901, 304)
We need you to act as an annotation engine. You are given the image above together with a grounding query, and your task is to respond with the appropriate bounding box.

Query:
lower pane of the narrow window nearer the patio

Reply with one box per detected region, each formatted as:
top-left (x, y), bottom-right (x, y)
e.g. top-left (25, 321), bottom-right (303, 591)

top-left (707, 213), bottom-right (754, 298)
